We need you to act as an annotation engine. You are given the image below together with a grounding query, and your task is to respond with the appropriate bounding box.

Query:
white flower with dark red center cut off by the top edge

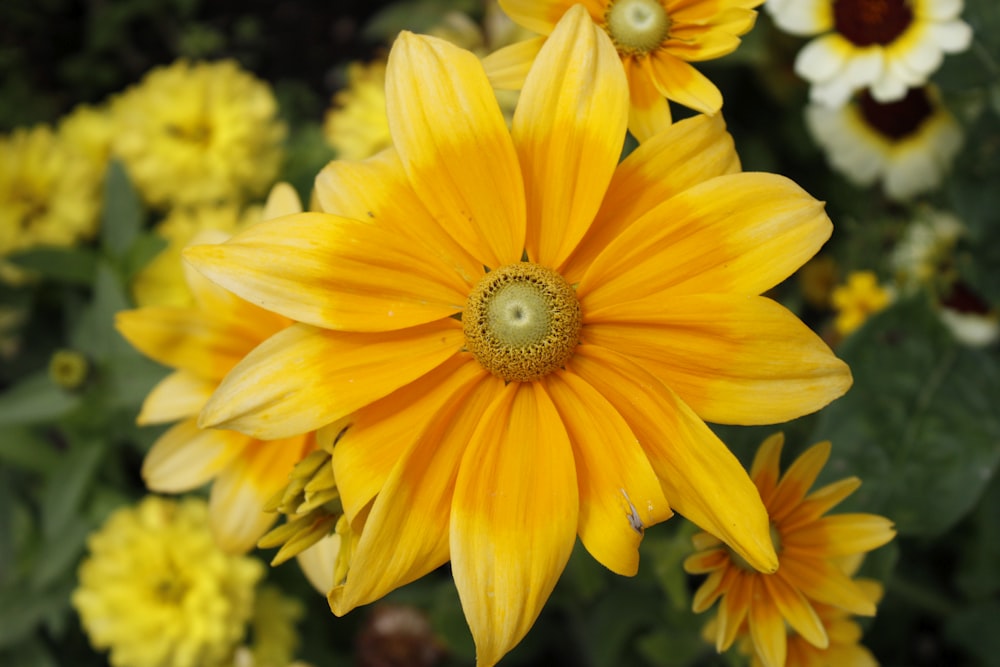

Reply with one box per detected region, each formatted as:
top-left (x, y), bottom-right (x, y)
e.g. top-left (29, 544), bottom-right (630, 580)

top-left (764, 0), bottom-right (972, 107)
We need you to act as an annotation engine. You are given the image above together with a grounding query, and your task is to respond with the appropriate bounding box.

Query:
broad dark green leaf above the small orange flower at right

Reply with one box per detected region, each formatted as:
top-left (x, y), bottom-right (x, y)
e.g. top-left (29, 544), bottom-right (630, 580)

top-left (812, 301), bottom-right (1000, 537)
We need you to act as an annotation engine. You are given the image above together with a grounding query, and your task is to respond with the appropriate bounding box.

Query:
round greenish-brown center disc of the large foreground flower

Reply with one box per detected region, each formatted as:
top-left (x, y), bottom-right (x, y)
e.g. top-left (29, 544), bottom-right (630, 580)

top-left (462, 262), bottom-right (583, 382)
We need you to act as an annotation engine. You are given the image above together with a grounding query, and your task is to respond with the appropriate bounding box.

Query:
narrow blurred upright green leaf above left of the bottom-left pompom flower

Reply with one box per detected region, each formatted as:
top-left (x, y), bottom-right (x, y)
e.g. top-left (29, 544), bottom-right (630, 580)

top-left (41, 440), bottom-right (106, 540)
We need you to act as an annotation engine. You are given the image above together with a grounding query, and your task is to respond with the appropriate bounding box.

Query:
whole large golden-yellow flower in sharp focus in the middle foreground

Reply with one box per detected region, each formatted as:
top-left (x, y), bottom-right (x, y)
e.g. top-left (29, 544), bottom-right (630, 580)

top-left (186, 8), bottom-right (850, 665)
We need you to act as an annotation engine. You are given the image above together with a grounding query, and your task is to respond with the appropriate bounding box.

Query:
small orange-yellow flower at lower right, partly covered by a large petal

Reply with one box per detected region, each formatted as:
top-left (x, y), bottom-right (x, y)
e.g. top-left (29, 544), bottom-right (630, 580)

top-left (684, 433), bottom-right (895, 667)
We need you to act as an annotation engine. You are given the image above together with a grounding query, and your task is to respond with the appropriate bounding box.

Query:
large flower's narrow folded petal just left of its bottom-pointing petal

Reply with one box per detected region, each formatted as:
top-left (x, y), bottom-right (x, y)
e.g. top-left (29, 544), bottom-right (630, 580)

top-left (329, 370), bottom-right (503, 615)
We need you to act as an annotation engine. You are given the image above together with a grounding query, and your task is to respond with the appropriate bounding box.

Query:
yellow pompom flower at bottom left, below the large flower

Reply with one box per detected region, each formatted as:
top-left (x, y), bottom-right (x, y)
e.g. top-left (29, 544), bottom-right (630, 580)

top-left (72, 496), bottom-right (264, 667)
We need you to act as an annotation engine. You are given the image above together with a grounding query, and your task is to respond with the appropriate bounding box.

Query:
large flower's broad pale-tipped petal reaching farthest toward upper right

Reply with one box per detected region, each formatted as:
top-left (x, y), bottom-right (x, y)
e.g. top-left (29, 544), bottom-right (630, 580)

top-left (577, 173), bottom-right (833, 310)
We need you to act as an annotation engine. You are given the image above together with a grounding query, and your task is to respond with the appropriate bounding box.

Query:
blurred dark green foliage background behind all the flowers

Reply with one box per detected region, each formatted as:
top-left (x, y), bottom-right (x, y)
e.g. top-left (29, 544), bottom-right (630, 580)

top-left (0, 0), bottom-right (1000, 667)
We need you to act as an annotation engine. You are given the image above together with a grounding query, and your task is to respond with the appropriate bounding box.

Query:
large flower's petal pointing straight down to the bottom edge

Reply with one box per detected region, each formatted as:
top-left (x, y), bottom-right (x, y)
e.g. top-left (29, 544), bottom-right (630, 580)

top-left (451, 382), bottom-right (579, 667)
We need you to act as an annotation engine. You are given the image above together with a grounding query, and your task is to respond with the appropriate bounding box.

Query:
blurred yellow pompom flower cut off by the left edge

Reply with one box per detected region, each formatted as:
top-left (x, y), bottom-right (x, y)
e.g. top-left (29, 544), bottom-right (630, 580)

top-left (0, 125), bottom-right (103, 282)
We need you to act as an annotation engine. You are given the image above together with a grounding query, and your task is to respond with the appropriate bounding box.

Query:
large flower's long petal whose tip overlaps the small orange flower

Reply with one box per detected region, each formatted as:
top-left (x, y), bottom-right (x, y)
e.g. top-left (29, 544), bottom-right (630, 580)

top-left (568, 345), bottom-right (778, 572)
